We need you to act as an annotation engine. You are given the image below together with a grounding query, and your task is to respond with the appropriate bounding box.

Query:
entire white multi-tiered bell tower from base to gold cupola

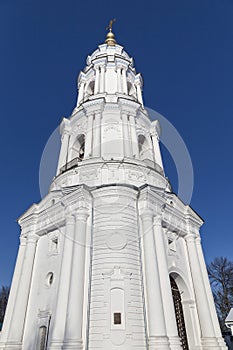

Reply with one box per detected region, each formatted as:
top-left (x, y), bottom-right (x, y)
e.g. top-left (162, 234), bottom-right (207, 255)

top-left (0, 32), bottom-right (226, 350)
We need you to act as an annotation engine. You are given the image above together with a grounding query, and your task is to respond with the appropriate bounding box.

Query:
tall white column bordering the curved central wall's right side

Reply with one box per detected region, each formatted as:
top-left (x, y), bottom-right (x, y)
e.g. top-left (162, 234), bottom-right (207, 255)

top-left (141, 209), bottom-right (170, 350)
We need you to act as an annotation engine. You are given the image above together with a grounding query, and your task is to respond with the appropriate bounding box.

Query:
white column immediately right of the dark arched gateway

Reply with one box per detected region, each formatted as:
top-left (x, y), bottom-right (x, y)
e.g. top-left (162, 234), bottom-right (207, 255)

top-left (185, 234), bottom-right (218, 350)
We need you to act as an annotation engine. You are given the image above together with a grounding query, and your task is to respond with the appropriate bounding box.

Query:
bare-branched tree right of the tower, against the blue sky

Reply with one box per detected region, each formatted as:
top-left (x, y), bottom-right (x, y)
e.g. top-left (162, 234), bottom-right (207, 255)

top-left (207, 257), bottom-right (233, 331)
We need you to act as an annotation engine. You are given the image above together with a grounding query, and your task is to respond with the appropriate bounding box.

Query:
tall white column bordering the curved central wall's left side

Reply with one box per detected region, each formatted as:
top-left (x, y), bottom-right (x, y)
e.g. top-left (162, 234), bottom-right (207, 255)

top-left (63, 208), bottom-right (89, 350)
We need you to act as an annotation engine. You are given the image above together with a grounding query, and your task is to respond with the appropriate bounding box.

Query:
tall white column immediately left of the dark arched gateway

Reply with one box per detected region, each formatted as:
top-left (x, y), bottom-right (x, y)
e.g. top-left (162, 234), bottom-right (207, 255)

top-left (154, 216), bottom-right (182, 350)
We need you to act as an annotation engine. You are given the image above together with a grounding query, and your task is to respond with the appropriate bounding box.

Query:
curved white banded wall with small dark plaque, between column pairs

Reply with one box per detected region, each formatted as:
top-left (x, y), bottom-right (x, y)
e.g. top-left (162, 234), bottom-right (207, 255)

top-left (88, 186), bottom-right (146, 350)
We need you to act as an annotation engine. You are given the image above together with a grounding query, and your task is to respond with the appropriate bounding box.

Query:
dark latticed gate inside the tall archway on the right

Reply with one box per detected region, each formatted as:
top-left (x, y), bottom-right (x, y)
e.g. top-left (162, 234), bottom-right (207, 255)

top-left (170, 276), bottom-right (189, 350)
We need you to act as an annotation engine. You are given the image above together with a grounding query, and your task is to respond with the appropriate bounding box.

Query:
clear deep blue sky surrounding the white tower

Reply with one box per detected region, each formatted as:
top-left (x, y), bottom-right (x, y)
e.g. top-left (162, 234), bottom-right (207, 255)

top-left (0, 0), bottom-right (233, 285)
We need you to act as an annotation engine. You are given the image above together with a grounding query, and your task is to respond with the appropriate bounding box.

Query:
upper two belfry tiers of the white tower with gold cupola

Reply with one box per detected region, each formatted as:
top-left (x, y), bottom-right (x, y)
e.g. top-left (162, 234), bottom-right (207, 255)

top-left (57, 23), bottom-right (163, 179)
